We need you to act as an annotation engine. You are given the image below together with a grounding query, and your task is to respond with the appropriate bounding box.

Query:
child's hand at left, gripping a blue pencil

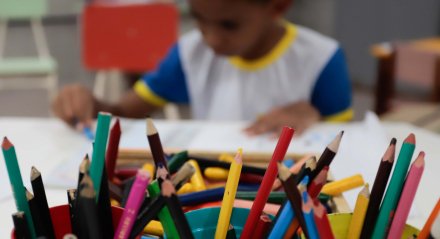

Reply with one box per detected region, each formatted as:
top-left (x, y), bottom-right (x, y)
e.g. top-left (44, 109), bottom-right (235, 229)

top-left (52, 84), bottom-right (97, 130)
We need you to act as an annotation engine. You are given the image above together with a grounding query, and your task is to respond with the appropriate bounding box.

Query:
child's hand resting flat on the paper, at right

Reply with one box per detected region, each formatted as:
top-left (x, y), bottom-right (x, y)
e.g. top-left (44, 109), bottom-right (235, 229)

top-left (244, 101), bottom-right (320, 136)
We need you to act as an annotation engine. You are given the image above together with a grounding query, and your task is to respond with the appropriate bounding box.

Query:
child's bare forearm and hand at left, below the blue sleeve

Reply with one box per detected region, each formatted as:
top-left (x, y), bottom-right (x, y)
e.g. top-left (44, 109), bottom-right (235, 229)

top-left (52, 84), bottom-right (158, 127)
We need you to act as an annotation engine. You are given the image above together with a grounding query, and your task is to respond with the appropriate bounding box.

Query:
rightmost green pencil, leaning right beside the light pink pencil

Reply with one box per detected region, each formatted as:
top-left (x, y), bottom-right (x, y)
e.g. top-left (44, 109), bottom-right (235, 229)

top-left (371, 134), bottom-right (416, 238)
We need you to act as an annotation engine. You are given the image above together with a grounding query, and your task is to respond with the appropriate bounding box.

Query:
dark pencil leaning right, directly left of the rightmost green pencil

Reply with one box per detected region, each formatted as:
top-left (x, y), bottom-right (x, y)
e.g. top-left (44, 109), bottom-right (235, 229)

top-left (360, 138), bottom-right (396, 239)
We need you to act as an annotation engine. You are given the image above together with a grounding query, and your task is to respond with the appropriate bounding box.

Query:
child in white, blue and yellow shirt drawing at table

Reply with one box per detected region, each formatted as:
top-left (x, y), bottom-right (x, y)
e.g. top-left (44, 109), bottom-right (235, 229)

top-left (53, 0), bottom-right (353, 135)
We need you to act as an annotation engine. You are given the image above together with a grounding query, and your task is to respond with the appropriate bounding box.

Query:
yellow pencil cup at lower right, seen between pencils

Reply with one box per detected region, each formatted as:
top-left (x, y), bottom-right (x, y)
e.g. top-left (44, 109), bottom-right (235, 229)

top-left (328, 213), bottom-right (420, 239)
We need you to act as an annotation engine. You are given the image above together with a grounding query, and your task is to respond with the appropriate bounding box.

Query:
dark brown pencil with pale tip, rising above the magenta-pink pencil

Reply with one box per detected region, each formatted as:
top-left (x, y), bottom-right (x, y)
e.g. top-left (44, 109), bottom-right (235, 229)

top-left (147, 118), bottom-right (168, 171)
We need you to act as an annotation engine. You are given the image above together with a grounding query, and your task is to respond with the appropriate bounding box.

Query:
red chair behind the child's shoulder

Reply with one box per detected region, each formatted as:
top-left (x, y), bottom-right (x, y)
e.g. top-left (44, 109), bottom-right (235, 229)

top-left (82, 3), bottom-right (179, 118)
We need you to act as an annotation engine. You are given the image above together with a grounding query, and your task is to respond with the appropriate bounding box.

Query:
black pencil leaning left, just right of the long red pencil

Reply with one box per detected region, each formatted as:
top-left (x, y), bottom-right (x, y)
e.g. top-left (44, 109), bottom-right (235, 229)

top-left (278, 162), bottom-right (310, 238)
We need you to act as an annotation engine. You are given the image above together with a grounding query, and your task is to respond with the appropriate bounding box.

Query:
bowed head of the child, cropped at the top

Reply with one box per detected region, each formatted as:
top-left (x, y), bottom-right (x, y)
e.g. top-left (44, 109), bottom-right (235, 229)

top-left (188, 0), bottom-right (291, 58)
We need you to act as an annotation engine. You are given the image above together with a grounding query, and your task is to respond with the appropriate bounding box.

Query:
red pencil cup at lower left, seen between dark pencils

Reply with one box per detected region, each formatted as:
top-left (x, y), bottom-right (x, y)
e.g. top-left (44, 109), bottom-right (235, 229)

top-left (11, 205), bottom-right (124, 239)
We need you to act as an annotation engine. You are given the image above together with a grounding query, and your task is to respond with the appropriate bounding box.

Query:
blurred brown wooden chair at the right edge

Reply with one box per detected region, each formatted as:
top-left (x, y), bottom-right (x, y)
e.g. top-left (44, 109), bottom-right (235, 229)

top-left (372, 38), bottom-right (440, 114)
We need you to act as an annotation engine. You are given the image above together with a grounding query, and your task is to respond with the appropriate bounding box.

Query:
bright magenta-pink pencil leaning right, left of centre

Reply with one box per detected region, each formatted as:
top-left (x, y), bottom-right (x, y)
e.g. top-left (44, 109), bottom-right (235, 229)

top-left (114, 169), bottom-right (150, 239)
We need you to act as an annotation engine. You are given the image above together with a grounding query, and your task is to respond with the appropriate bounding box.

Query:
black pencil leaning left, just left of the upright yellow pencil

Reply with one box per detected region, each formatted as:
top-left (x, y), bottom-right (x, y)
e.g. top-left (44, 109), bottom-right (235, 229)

top-left (161, 179), bottom-right (193, 238)
